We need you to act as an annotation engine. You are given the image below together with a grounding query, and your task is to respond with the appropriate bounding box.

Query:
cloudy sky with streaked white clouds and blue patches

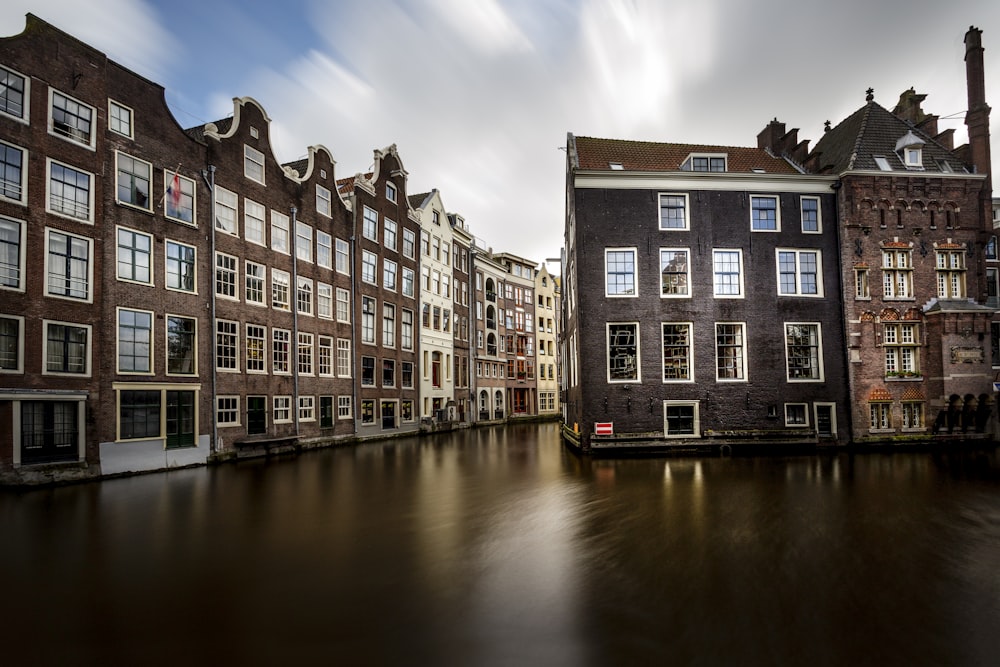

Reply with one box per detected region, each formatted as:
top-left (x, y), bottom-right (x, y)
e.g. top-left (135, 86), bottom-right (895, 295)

top-left (0, 0), bottom-right (1000, 261)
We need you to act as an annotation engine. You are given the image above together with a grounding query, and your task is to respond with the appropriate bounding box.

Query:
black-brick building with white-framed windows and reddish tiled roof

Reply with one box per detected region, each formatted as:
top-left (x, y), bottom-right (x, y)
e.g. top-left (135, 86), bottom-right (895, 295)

top-left (563, 133), bottom-right (848, 451)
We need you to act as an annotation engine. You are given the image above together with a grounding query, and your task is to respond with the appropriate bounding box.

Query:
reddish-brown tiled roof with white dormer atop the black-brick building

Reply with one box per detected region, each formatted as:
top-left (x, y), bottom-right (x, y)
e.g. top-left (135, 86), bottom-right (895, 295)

top-left (575, 137), bottom-right (800, 174)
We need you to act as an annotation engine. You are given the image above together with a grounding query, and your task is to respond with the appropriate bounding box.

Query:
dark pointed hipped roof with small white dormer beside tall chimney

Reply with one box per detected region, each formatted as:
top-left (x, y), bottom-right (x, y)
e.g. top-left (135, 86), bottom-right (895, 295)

top-left (810, 101), bottom-right (966, 173)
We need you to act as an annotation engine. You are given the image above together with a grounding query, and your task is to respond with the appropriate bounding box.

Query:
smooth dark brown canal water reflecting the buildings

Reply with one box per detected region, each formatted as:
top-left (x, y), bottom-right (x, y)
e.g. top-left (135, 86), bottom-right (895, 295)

top-left (0, 424), bottom-right (1000, 666)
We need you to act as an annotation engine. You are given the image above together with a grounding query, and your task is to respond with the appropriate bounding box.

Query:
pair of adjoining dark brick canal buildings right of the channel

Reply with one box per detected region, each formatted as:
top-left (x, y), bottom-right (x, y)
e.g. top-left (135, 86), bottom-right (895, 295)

top-left (563, 28), bottom-right (1000, 452)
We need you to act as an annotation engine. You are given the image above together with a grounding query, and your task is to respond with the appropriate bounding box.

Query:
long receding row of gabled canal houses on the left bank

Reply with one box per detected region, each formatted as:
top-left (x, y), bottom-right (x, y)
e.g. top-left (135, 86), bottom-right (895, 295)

top-left (0, 14), bottom-right (559, 484)
